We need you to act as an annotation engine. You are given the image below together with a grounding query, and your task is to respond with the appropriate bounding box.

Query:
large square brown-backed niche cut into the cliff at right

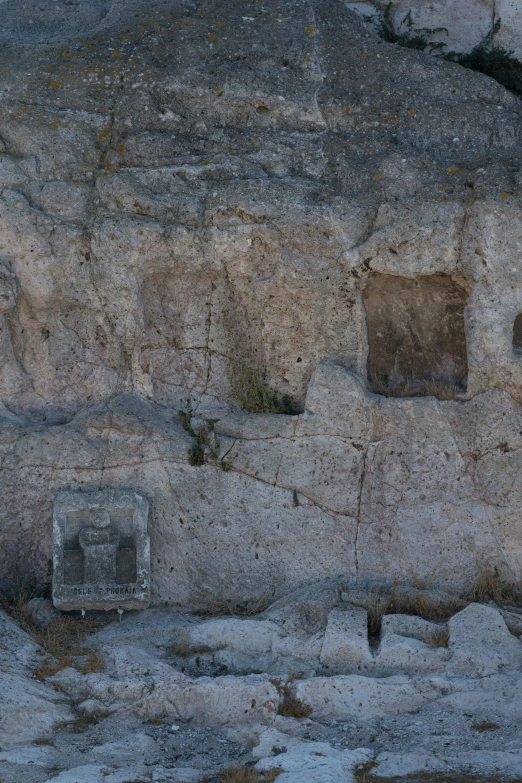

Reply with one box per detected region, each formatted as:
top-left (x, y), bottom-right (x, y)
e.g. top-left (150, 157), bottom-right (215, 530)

top-left (363, 273), bottom-right (468, 399)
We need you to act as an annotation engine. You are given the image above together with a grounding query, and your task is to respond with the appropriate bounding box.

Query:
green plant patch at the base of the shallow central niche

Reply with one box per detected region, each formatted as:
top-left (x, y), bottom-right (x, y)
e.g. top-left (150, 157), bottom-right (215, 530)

top-left (229, 362), bottom-right (299, 416)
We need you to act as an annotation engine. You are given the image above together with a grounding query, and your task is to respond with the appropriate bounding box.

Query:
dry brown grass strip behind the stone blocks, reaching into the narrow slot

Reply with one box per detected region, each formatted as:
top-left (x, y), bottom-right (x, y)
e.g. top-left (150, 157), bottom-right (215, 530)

top-left (366, 587), bottom-right (468, 636)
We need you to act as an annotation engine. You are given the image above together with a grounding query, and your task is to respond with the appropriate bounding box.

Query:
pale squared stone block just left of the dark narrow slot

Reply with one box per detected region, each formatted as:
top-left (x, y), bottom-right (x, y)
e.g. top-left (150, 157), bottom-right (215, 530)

top-left (320, 607), bottom-right (373, 672)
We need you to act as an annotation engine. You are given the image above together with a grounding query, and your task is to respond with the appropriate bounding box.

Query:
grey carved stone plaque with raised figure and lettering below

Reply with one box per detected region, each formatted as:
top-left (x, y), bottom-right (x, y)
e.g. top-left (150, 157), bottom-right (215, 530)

top-left (53, 489), bottom-right (150, 610)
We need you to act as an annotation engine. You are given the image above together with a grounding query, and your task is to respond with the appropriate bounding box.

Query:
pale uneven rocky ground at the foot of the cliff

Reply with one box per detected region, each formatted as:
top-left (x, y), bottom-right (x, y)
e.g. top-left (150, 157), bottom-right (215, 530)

top-left (0, 582), bottom-right (522, 783)
